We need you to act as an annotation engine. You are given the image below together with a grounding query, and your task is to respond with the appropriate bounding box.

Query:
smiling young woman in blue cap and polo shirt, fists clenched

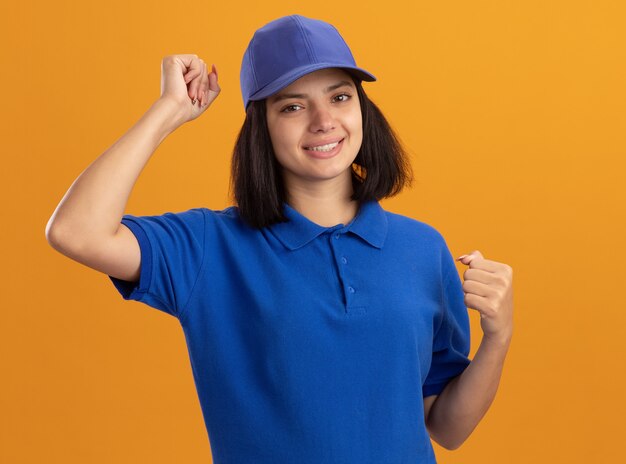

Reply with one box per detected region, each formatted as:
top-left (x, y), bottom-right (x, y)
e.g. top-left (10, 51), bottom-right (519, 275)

top-left (46, 15), bottom-right (513, 464)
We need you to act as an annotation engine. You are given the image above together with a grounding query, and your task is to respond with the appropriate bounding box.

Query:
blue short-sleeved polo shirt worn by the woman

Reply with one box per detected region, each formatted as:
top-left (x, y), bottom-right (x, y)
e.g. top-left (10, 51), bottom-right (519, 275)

top-left (109, 201), bottom-right (470, 464)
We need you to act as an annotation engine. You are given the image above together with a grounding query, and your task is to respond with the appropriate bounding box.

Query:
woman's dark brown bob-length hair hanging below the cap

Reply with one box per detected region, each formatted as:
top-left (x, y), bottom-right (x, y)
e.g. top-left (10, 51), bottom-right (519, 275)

top-left (230, 77), bottom-right (413, 228)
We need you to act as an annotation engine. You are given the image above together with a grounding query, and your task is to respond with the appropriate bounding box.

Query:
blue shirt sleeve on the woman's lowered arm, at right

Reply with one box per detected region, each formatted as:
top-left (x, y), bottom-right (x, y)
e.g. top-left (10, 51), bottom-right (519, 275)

top-left (422, 241), bottom-right (471, 397)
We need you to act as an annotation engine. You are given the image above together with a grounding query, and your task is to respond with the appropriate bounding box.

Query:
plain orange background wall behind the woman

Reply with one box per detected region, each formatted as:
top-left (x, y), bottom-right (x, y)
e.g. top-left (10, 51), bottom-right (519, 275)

top-left (0, 0), bottom-right (626, 464)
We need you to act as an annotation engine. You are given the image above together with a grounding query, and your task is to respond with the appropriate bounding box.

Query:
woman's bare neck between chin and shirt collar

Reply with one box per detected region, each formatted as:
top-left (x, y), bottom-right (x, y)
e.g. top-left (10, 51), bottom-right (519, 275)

top-left (285, 171), bottom-right (358, 227)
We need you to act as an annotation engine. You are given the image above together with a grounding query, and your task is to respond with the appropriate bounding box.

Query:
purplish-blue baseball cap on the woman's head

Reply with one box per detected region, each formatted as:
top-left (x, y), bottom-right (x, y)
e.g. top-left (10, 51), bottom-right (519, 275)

top-left (240, 15), bottom-right (376, 110)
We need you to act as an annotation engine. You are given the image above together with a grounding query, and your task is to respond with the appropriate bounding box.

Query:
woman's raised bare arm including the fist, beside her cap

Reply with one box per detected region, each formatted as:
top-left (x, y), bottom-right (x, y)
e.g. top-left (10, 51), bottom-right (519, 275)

top-left (46, 55), bottom-right (220, 280)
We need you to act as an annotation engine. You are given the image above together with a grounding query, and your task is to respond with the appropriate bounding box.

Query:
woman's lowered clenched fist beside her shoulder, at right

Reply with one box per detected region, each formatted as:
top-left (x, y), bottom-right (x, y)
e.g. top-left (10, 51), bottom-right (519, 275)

top-left (456, 250), bottom-right (513, 345)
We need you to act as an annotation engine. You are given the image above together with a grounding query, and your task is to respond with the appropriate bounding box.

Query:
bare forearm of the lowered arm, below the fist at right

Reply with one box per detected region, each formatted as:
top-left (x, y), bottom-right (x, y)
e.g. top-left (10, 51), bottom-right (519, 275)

top-left (427, 338), bottom-right (510, 449)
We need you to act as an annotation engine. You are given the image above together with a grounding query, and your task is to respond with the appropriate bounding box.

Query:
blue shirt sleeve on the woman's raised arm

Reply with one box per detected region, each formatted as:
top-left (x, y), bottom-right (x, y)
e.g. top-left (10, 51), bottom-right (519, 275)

top-left (109, 208), bottom-right (205, 318)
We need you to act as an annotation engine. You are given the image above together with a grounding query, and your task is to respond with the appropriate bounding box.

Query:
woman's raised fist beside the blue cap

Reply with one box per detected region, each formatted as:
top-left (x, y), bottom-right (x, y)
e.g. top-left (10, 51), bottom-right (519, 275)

top-left (161, 54), bottom-right (221, 125)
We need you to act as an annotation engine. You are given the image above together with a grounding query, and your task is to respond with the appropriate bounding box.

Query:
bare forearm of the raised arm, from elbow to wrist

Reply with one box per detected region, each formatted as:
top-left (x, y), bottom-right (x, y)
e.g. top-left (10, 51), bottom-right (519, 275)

top-left (46, 99), bottom-right (179, 245)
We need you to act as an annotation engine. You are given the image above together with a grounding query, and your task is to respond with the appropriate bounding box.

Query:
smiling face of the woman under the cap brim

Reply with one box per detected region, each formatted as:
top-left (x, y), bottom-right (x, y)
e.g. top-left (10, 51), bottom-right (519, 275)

top-left (266, 68), bottom-right (363, 189)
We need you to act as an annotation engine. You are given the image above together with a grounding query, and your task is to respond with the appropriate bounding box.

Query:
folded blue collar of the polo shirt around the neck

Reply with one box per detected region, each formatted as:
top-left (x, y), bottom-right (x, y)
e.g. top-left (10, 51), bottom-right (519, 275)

top-left (269, 200), bottom-right (387, 250)
